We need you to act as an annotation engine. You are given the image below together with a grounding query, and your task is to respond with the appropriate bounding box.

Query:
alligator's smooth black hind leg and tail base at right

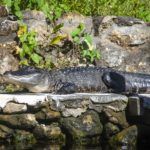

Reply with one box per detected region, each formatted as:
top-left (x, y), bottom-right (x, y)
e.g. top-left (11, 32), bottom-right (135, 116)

top-left (102, 71), bottom-right (150, 94)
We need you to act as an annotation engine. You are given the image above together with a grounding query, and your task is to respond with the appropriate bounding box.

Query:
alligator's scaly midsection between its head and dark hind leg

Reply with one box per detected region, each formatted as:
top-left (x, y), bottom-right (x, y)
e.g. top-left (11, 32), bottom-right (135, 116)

top-left (49, 67), bottom-right (110, 94)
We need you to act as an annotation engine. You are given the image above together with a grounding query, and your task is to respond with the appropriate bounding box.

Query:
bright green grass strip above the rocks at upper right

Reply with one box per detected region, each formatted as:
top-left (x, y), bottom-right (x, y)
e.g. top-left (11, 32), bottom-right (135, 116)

top-left (58, 0), bottom-right (150, 21)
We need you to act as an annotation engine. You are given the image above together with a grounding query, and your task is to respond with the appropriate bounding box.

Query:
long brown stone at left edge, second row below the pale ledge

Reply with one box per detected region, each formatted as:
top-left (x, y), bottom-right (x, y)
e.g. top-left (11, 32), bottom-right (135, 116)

top-left (0, 114), bottom-right (37, 130)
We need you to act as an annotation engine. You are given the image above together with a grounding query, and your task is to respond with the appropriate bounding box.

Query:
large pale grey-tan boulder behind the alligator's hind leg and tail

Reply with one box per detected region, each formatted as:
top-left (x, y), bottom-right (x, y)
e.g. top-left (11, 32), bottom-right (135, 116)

top-left (94, 16), bottom-right (150, 73)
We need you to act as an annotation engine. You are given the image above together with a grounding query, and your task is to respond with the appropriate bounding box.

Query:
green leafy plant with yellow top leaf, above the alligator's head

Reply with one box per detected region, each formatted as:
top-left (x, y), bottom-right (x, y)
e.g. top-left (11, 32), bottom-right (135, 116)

top-left (18, 24), bottom-right (42, 65)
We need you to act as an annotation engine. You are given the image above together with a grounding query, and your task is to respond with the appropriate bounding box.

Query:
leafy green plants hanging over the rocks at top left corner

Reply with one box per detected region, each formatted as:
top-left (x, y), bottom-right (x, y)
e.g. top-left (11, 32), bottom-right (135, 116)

top-left (3, 0), bottom-right (69, 21)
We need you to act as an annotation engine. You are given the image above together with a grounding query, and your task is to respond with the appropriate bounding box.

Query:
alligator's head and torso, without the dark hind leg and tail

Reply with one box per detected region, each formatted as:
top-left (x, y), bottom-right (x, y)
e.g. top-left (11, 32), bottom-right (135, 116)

top-left (3, 66), bottom-right (109, 94)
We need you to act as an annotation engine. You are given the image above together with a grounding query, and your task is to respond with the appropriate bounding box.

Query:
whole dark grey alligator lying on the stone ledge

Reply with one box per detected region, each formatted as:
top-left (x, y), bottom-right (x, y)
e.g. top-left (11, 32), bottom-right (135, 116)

top-left (3, 66), bottom-right (150, 94)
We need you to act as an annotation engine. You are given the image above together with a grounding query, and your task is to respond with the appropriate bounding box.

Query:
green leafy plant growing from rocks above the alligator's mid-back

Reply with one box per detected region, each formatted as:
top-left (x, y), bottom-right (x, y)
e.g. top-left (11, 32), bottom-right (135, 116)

top-left (71, 24), bottom-right (100, 63)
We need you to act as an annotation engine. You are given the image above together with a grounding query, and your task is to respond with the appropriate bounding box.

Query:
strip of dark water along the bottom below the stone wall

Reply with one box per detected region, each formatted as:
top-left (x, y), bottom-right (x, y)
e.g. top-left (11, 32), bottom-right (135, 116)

top-left (0, 140), bottom-right (150, 150)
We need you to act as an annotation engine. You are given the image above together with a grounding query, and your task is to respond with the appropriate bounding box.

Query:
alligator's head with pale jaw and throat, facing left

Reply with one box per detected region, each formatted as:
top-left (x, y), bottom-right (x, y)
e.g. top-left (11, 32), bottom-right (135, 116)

top-left (3, 66), bottom-right (49, 92)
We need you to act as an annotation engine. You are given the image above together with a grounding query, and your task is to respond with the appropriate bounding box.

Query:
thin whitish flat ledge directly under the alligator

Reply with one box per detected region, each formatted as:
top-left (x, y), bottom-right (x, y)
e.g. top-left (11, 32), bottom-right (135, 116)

top-left (0, 93), bottom-right (128, 108)
